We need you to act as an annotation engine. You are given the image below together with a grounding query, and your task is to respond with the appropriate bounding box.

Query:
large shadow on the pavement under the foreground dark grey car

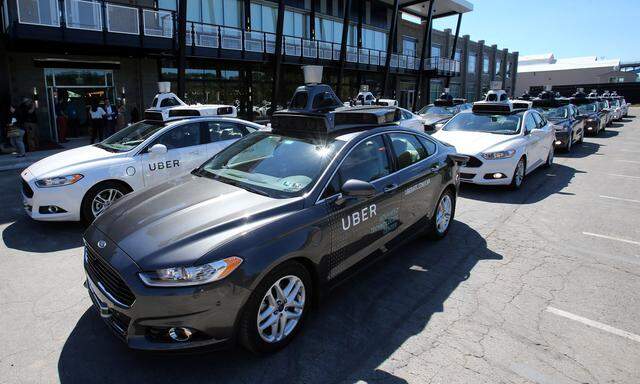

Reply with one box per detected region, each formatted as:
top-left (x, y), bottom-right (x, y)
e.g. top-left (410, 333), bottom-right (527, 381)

top-left (58, 221), bottom-right (502, 383)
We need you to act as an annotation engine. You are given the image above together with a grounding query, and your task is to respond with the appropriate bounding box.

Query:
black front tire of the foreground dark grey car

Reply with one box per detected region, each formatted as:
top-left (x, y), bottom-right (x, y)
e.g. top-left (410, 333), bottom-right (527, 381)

top-left (238, 261), bottom-right (313, 355)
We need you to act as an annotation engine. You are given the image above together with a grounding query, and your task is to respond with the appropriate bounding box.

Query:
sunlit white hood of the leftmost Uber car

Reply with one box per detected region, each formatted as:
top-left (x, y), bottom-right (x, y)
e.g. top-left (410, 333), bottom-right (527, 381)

top-left (27, 145), bottom-right (122, 177)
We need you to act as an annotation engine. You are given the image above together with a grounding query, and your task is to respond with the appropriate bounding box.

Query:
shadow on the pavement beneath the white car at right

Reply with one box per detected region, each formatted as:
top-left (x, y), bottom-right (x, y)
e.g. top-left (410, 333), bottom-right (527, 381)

top-left (460, 164), bottom-right (585, 204)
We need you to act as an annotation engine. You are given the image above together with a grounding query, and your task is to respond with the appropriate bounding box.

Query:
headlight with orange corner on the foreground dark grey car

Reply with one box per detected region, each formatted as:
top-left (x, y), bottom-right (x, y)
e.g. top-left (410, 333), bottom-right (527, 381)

top-left (139, 256), bottom-right (242, 287)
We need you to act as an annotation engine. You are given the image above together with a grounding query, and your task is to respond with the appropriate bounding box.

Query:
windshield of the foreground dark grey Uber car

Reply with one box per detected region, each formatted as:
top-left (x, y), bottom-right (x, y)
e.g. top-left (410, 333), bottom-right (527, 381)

top-left (196, 132), bottom-right (345, 198)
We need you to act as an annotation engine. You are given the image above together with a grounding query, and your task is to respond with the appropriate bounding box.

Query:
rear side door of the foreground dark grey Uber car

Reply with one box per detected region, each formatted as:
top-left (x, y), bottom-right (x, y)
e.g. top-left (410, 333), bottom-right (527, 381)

top-left (387, 132), bottom-right (446, 237)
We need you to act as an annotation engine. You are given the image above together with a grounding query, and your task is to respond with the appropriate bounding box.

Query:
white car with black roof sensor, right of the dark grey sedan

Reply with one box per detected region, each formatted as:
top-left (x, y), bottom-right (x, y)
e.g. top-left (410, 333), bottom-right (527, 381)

top-left (432, 95), bottom-right (555, 189)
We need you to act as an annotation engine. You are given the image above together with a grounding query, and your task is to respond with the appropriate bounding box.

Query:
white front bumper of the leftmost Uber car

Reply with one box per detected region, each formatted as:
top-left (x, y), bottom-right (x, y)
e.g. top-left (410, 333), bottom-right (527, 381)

top-left (21, 170), bottom-right (85, 221)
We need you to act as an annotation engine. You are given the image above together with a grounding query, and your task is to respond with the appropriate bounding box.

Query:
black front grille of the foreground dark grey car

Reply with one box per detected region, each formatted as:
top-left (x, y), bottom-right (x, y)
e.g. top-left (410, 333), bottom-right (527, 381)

top-left (85, 247), bottom-right (136, 307)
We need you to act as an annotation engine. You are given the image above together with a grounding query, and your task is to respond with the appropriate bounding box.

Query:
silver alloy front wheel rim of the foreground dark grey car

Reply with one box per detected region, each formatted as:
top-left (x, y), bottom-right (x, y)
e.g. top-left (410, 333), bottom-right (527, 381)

top-left (256, 275), bottom-right (306, 343)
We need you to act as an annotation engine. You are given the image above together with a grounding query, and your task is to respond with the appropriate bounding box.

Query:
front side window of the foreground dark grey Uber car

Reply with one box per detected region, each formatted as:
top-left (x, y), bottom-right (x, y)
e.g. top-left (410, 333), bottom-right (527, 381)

top-left (323, 135), bottom-right (391, 197)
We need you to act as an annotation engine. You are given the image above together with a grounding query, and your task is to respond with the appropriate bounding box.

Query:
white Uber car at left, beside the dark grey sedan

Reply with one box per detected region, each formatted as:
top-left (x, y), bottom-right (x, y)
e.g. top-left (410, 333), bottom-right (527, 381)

top-left (21, 106), bottom-right (264, 223)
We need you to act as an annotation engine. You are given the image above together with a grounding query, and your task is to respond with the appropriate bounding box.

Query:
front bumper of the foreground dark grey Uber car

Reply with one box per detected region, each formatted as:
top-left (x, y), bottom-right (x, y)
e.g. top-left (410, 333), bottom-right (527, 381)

top-left (84, 231), bottom-right (251, 351)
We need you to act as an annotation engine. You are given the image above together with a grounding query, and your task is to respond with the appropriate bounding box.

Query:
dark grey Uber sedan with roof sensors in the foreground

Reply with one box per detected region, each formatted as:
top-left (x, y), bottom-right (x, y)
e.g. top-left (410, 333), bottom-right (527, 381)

top-left (84, 83), bottom-right (467, 353)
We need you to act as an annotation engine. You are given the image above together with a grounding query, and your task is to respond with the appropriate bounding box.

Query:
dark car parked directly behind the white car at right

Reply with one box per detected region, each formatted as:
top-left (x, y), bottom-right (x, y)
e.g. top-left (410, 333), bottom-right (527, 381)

top-left (532, 92), bottom-right (584, 152)
